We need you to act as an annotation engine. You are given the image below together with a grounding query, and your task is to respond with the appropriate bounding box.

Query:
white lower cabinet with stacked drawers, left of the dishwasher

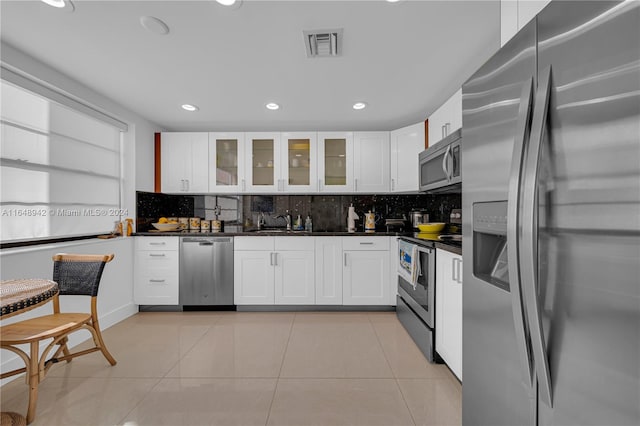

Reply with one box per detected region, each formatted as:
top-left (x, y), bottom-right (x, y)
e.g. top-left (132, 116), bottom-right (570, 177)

top-left (133, 237), bottom-right (179, 305)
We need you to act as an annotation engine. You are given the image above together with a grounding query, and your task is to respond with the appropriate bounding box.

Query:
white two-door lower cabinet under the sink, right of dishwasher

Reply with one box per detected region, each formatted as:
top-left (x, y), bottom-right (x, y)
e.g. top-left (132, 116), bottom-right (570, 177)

top-left (233, 236), bottom-right (315, 305)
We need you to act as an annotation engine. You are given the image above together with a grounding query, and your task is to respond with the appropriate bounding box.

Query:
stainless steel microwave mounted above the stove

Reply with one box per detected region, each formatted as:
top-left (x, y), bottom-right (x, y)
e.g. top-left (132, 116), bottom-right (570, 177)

top-left (419, 129), bottom-right (462, 193)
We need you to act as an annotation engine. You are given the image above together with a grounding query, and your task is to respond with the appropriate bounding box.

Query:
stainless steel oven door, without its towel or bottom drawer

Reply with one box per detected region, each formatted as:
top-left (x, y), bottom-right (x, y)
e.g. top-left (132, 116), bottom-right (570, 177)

top-left (398, 246), bottom-right (436, 328)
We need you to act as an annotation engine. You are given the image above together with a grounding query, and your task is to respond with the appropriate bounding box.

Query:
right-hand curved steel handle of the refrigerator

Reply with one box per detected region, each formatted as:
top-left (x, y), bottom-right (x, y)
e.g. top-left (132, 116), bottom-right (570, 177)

top-left (521, 67), bottom-right (553, 407)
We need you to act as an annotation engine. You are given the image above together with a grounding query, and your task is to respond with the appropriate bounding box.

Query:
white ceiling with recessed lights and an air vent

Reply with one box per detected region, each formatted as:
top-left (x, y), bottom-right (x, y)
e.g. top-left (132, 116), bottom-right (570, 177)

top-left (0, 0), bottom-right (500, 131)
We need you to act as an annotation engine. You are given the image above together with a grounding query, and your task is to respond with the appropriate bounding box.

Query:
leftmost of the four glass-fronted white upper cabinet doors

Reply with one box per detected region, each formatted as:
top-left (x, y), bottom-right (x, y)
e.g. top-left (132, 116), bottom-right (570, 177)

top-left (209, 133), bottom-right (245, 193)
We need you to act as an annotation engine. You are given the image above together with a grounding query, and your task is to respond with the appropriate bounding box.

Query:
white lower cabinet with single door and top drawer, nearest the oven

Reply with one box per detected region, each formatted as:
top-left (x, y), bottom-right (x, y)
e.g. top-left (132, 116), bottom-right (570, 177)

top-left (342, 237), bottom-right (391, 305)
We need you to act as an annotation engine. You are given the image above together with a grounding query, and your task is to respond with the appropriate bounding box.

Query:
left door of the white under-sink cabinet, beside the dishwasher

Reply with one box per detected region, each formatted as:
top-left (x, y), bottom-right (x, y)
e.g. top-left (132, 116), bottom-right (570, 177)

top-left (233, 251), bottom-right (274, 305)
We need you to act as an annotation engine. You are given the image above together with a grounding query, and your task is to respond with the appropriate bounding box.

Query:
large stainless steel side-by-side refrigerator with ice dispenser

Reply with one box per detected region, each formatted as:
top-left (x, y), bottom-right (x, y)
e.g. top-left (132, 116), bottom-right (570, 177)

top-left (462, 1), bottom-right (640, 426)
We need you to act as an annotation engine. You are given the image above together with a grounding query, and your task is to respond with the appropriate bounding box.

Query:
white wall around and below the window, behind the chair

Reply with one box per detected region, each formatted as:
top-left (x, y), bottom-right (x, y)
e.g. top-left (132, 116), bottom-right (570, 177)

top-left (0, 43), bottom-right (164, 380)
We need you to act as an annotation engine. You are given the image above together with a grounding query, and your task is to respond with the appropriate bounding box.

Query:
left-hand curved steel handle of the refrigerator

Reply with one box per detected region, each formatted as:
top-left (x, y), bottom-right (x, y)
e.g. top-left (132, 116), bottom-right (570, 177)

top-left (507, 77), bottom-right (533, 388)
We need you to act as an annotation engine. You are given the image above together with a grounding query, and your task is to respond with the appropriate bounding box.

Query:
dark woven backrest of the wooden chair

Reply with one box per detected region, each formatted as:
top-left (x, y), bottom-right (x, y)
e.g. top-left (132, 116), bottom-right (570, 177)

top-left (53, 253), bottom-right (114, 297)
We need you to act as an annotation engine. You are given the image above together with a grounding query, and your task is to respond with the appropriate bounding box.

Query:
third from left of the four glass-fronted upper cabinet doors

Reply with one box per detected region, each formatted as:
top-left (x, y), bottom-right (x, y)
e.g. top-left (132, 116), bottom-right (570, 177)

top-left (281, 132), bottom-right (318, 193)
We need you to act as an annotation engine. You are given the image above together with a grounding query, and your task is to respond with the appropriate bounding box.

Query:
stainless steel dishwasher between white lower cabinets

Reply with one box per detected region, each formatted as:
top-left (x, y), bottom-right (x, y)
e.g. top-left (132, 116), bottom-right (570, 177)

top-left (180, 236), bottom-right (233, 309)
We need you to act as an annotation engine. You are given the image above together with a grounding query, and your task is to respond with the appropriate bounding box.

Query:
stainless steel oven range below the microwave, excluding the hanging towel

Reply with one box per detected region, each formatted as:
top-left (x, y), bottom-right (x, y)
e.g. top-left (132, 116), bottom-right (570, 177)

top-left (396, 240), bottom-right (438, 362)
